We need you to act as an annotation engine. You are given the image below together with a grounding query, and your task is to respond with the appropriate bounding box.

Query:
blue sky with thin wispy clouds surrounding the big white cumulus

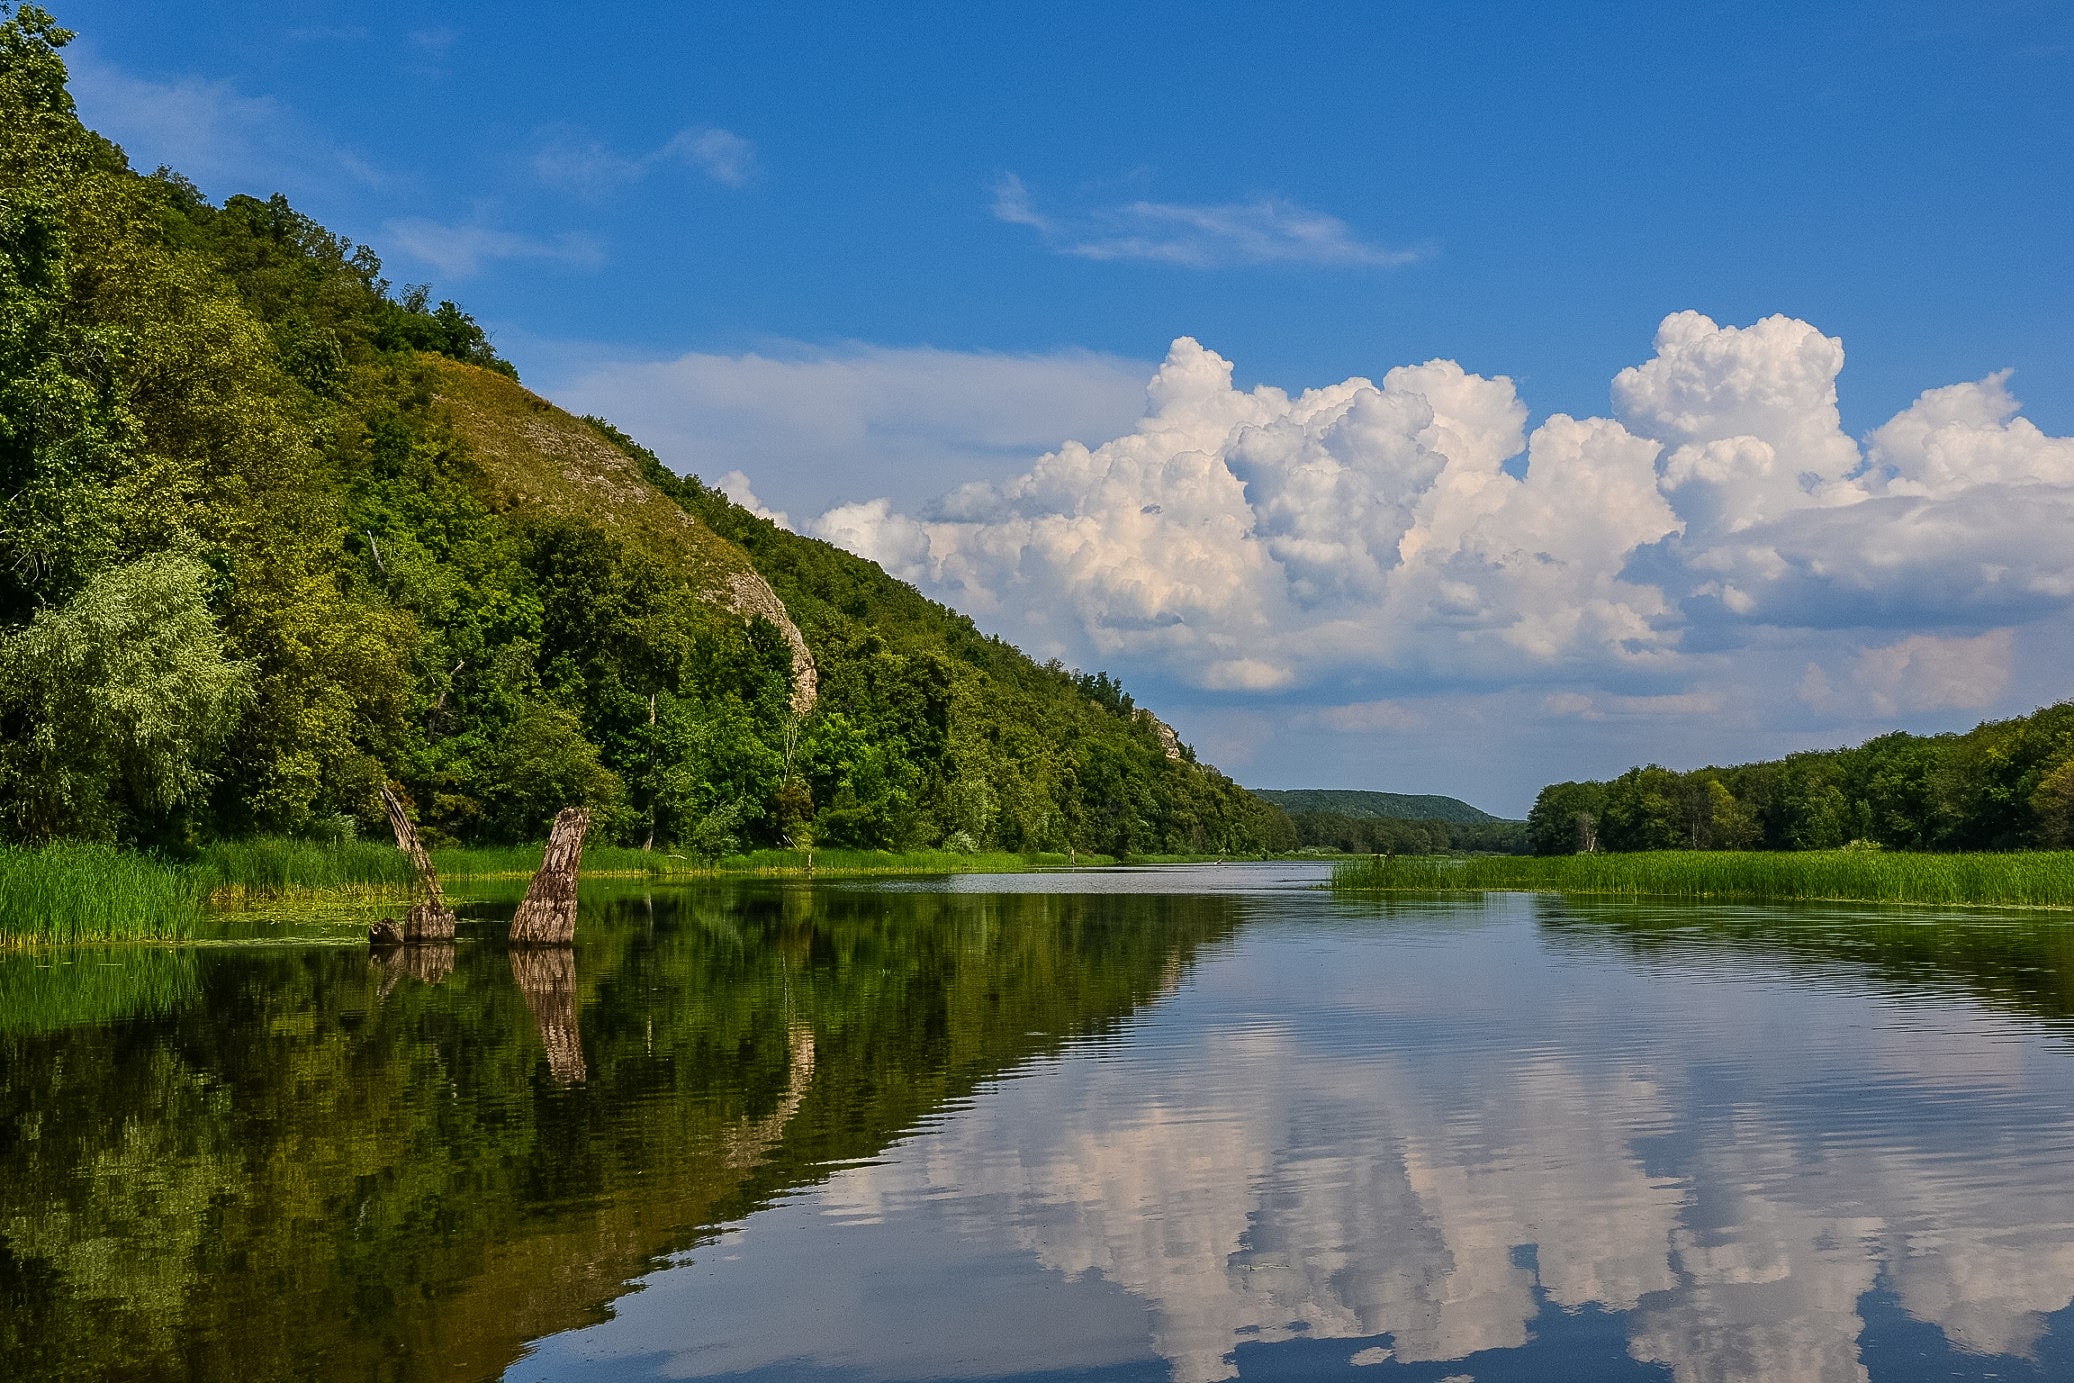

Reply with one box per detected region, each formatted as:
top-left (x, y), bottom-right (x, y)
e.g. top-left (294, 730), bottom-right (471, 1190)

top-left (56, 0), bottom-right (2074, 809)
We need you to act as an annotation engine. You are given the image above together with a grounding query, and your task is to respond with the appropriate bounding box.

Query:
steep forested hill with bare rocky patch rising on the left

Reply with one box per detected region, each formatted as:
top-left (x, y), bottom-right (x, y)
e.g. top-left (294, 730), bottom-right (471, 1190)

top-left (0, 6), bottom-right (1290, 854)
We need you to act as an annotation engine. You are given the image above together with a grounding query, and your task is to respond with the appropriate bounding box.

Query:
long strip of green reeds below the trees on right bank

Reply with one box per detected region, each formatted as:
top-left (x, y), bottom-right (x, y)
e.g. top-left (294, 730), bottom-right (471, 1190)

top-left (1332, 850), bottom-right (2074, 908)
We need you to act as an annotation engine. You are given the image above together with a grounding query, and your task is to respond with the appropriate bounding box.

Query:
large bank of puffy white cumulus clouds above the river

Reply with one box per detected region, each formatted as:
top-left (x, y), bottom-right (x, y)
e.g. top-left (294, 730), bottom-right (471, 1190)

top-left (788, 313), bottom-right (2074, 724)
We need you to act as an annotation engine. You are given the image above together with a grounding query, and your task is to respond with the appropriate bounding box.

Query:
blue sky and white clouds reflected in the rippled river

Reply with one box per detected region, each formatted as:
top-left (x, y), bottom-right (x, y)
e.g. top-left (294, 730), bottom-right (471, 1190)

top-left (508, 894), bottom-right (2074, 1383)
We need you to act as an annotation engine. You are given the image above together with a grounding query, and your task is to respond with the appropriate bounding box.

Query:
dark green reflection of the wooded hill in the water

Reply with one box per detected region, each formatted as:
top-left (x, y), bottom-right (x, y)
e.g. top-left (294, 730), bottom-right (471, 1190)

top-left (0, 885), bottom-right (1238, 1383)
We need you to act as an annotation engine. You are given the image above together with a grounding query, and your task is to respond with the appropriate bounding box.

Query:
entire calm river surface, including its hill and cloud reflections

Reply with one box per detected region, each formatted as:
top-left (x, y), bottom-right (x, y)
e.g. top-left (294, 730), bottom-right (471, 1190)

top-left (0, 867), bottom-right (2074, 1383)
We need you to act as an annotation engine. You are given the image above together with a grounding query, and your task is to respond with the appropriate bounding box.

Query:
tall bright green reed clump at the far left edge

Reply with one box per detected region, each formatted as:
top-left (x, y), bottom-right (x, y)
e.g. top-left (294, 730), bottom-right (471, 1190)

top-left (0, 844), bottom-right (207, 945)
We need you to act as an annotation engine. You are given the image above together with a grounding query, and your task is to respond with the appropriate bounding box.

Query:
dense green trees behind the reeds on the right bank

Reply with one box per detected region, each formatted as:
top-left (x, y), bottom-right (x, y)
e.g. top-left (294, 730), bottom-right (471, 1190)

top-left (1526, 701), bottom-right (2074, 854)
